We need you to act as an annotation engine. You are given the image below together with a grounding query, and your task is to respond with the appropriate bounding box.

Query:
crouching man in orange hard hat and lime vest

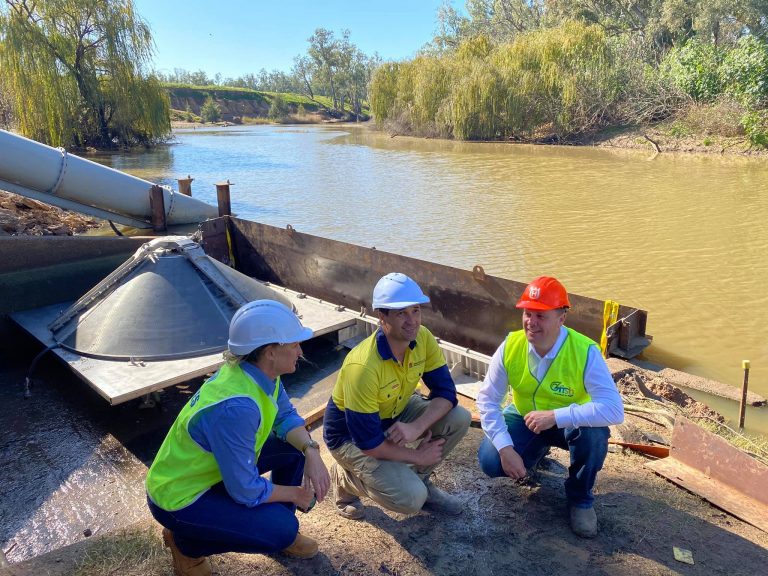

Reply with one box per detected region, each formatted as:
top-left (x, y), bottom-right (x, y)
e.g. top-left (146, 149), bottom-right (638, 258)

top-left (477, 276), bottom-right (624, 538)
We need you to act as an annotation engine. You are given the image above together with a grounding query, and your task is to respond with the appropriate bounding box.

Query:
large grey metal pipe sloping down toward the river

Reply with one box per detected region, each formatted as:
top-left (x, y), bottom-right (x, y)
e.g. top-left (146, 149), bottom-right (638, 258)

top-left (0, 130), bottom-right (218, 228)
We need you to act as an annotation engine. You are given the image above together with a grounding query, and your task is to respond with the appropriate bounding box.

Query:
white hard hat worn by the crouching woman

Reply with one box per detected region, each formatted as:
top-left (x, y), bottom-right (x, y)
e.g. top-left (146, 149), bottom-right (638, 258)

top-left (227, 300), bottom-right (312, 356)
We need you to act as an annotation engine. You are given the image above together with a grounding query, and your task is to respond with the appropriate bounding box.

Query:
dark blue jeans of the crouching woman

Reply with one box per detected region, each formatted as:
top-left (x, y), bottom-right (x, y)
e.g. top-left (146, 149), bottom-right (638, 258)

top-left (147, 435), bottom-right (304, 558)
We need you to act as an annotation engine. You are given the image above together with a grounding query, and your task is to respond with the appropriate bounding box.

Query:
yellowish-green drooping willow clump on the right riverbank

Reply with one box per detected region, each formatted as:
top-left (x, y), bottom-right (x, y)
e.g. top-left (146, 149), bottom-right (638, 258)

top-left (370, 22), bottom-right (620, 139)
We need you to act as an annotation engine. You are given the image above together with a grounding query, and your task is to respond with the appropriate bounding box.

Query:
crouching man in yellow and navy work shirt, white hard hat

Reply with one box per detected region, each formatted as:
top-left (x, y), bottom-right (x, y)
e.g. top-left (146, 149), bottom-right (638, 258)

top-left (323, 273), bottom-right (471, 520)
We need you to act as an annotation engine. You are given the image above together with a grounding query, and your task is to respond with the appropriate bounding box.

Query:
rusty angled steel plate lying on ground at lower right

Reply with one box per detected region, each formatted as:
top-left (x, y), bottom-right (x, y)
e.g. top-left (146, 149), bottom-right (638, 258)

top-left (646, 416), bottom-right (768, 532)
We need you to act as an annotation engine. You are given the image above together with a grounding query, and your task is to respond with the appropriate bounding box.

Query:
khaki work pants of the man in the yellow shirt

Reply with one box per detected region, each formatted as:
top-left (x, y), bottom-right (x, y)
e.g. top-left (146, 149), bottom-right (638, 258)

top-left (331, 394), bottom-right (472, 514)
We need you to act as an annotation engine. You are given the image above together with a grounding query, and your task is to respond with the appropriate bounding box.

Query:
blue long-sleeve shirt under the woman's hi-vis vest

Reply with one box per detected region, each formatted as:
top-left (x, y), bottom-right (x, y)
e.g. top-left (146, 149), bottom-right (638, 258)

top-left (189, 362), bottom-right (304, 506)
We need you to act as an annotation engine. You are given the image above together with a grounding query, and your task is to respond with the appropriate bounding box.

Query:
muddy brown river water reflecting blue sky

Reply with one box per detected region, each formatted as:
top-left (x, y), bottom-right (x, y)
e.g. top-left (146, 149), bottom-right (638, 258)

top-left (94, 126), bottom-right (768, 428)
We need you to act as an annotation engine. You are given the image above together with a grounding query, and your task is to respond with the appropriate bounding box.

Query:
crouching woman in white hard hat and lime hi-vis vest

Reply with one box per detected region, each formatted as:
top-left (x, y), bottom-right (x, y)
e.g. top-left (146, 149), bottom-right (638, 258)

top-left (146, 300), bottom-right (330, 576)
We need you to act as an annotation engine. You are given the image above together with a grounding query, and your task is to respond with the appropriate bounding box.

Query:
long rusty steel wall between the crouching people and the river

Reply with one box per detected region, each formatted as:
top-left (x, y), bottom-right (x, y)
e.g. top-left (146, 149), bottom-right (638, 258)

top-left (200, 217), bottom-right (649, 357)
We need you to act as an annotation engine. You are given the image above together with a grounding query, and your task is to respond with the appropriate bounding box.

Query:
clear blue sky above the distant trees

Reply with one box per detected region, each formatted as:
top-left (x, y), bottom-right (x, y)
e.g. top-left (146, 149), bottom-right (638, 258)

top-left (134, 0), bottom-right (463, 78)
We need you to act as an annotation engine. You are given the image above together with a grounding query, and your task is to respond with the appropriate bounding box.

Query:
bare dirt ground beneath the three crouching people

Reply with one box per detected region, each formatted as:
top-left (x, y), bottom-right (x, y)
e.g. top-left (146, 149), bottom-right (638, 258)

top-left (0, 363), bottom-right (768, 576)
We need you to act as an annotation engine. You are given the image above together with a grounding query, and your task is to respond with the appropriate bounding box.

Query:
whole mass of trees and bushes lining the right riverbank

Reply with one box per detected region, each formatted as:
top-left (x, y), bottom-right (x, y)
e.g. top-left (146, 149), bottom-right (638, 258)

top-left (370, 0), bottom-right (768, 144)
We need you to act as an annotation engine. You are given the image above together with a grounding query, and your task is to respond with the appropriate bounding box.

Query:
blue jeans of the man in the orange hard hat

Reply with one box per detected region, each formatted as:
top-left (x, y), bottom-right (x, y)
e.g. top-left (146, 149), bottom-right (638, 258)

top-left (478, 412), bottom-right (611, 508)
